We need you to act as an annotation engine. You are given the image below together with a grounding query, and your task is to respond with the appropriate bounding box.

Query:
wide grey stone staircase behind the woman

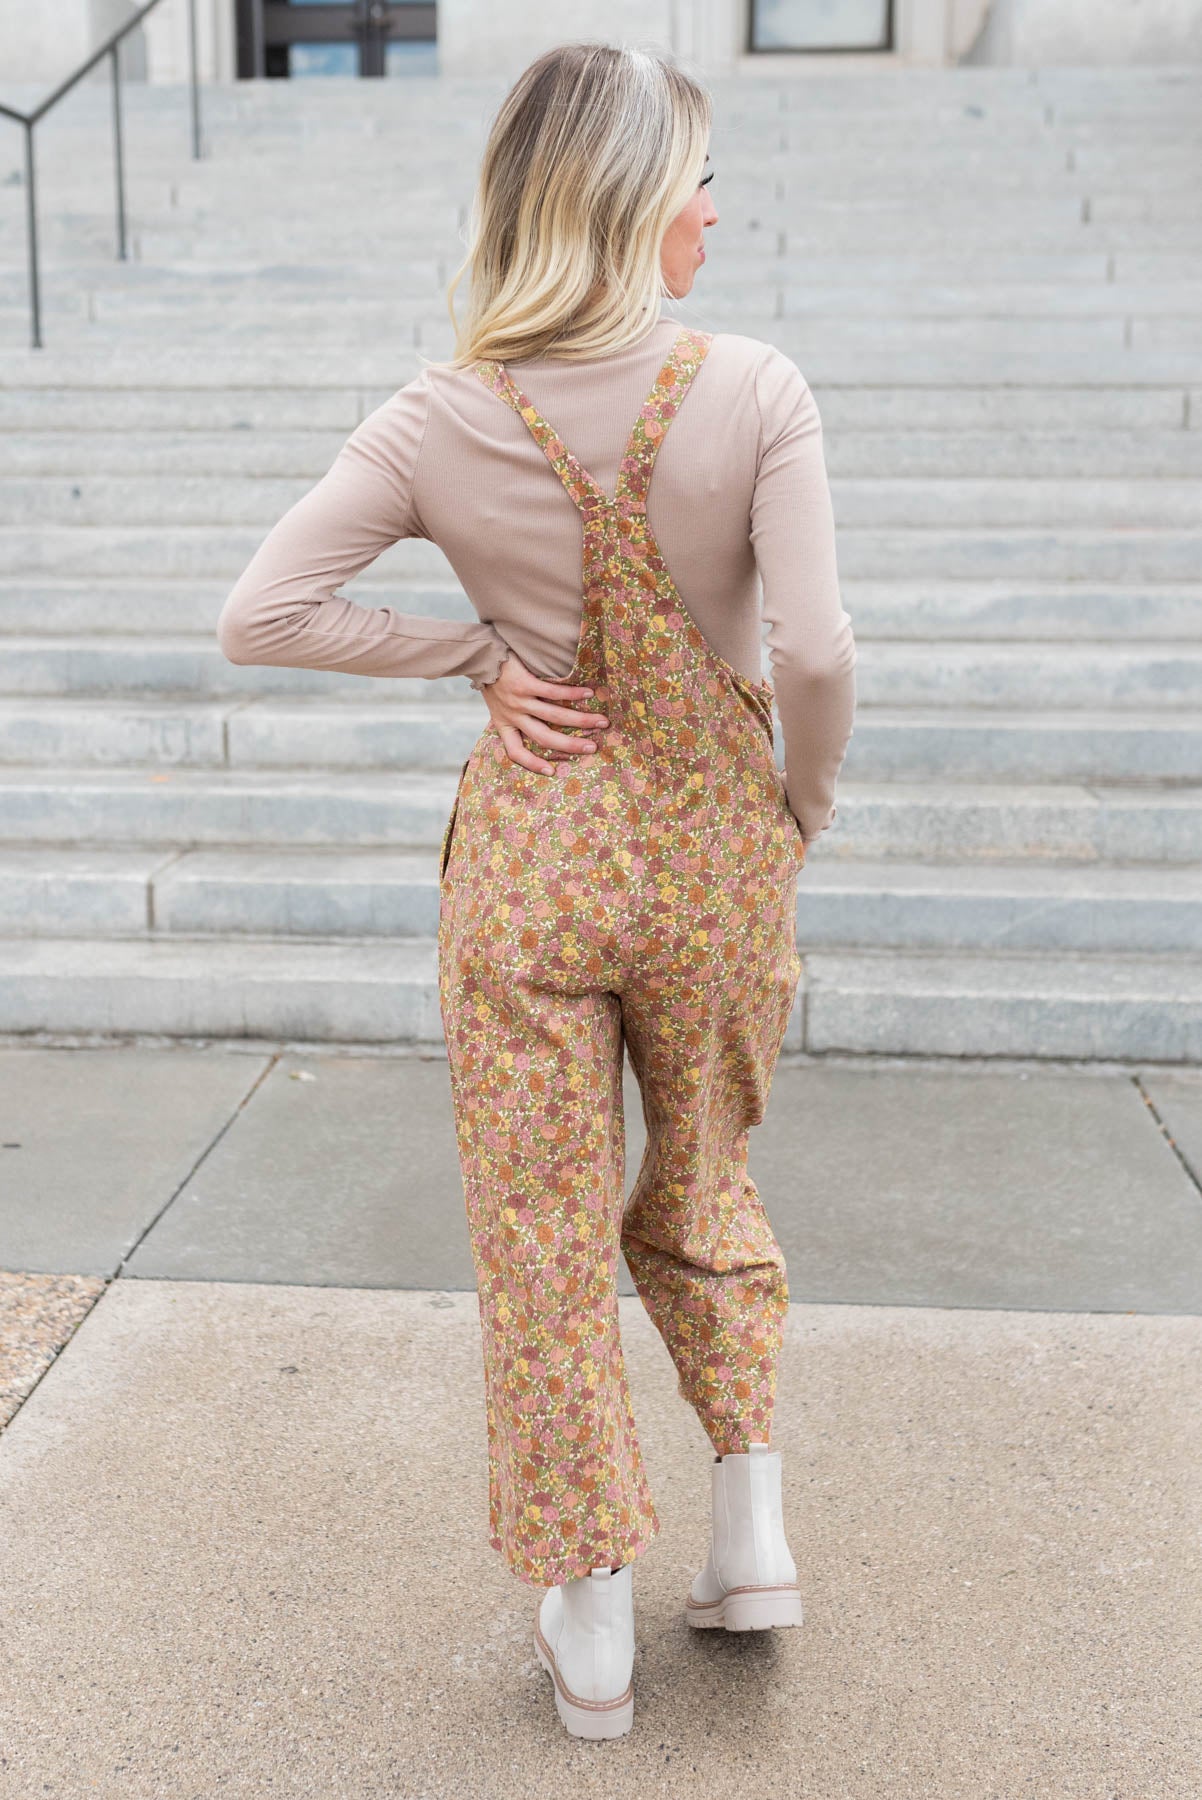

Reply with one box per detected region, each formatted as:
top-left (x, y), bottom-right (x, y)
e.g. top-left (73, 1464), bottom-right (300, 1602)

top-left (0, 68), bottom-right (1202, 1060)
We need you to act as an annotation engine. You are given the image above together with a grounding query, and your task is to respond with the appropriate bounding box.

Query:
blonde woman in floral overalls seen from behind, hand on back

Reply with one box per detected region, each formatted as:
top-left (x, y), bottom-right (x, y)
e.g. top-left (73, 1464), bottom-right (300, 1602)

top-left (218, 43), bottom-right (855, 1737)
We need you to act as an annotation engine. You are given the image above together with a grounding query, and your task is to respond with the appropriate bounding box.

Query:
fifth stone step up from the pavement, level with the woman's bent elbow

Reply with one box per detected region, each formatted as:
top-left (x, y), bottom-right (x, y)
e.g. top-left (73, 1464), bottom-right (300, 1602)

top-left (0, 634), bottom-right (1202, 709)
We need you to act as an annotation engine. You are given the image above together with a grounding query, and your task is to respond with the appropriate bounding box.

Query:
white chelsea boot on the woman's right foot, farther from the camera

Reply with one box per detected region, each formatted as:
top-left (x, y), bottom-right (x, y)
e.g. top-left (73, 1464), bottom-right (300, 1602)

top-left (684, 1444), bottom-right (801, 1631)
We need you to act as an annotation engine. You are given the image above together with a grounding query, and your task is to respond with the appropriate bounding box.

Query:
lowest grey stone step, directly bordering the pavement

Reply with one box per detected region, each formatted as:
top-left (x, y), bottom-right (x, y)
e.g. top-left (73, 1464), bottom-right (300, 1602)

top-left (0, 938), bottom-right (1202, 1062)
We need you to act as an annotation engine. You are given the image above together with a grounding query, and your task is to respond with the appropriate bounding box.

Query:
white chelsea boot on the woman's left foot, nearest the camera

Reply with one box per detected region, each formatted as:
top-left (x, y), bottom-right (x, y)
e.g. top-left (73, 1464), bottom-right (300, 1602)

top-left (534, 1562), bottom-right (635, 1737)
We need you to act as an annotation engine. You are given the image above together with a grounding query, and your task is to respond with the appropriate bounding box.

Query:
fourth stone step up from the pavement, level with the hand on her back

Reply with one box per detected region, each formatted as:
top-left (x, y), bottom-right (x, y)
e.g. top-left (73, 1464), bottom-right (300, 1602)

top-left (0, 697), bottom-right (1202, 783)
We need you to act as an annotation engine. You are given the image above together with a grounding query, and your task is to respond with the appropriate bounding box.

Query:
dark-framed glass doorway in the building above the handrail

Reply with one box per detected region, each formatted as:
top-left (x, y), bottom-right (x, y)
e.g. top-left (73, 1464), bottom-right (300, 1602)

top-left (236, 0), bottom-right (437, 79)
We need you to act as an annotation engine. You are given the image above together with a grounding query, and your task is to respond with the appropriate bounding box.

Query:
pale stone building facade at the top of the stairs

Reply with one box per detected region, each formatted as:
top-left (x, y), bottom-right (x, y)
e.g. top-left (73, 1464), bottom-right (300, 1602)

top-left (0, 0), bottom-right (1202, 83)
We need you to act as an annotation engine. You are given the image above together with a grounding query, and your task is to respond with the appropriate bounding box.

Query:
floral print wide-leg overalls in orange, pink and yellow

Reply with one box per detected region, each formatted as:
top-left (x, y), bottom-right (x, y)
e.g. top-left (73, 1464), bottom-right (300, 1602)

top-left (439, 326), bottom-right (804, 1586)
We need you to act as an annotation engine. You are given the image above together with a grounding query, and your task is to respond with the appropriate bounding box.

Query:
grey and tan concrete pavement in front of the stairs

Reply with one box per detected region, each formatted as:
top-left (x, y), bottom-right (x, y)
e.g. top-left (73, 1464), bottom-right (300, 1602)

top-left (0, 1044), bottom-right (1202, 1800)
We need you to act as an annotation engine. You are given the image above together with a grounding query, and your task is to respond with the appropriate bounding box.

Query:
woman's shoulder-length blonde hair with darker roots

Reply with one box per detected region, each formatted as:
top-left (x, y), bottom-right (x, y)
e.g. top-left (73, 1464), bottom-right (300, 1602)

top-left (430, 43), bottom-right (713, 369)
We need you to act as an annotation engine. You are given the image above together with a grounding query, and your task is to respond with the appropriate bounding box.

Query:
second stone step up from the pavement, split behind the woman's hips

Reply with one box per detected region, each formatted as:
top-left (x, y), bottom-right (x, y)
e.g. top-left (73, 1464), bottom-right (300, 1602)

top-left (0, 846), bottom-right (1202, 954)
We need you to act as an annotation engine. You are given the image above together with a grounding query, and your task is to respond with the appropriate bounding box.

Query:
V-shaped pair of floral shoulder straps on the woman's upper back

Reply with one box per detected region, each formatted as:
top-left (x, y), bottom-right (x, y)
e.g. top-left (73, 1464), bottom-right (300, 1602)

top-left (475, 326), bottom-right (711, 518)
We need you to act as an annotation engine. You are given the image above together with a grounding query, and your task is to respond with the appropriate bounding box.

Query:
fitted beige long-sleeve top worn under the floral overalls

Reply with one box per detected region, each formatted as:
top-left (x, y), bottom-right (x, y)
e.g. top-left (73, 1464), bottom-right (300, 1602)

top-left (218, 315), bottom-right (857, 839)
